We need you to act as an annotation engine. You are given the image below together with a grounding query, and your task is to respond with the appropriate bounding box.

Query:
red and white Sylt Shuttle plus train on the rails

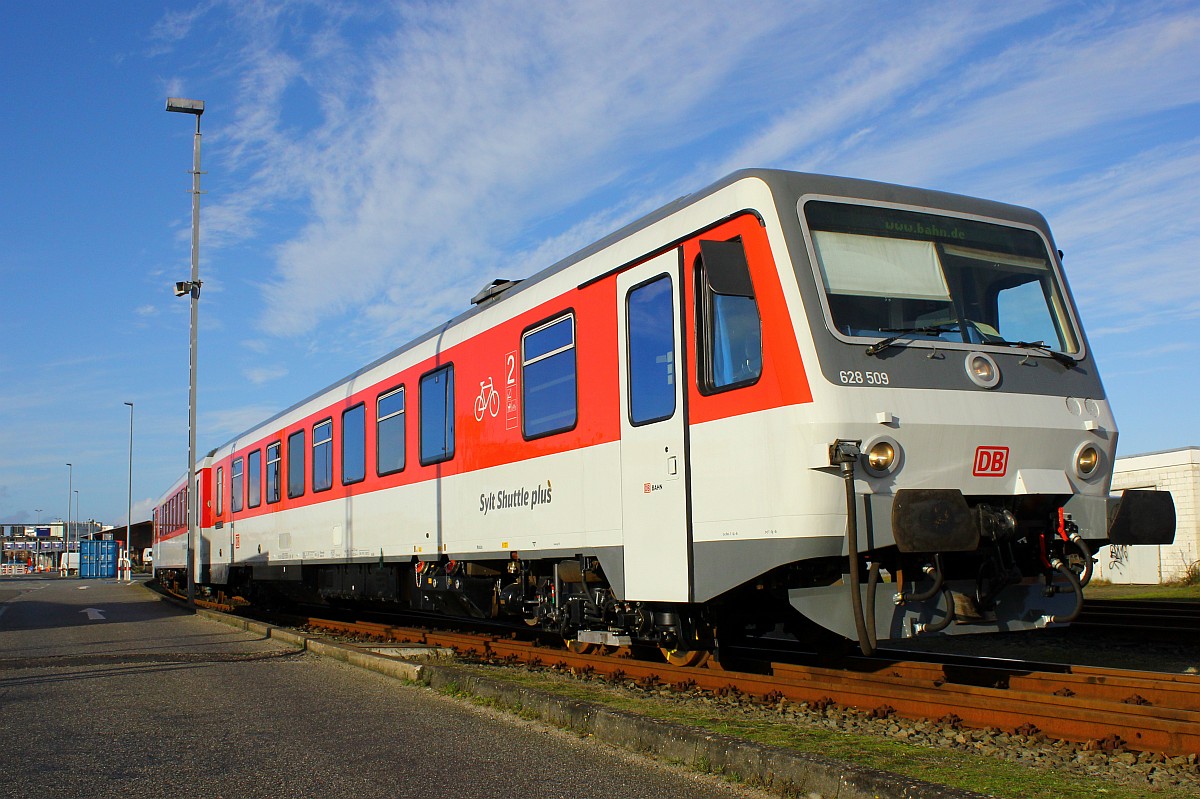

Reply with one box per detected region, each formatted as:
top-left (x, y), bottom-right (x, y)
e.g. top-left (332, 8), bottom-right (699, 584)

top-left (154, 169), bottom-right (1175, 663)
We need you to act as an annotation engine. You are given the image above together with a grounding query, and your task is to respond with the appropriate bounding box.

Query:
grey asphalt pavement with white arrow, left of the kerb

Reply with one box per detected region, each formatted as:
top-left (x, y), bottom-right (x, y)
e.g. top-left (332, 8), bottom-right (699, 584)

top-left (0, 576), bottom-right (762, 799)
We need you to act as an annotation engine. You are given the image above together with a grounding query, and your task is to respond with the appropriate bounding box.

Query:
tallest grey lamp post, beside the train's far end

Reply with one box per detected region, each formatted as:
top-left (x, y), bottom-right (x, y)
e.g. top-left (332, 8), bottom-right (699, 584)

top-left (167, 97), bottom-right (204, 608)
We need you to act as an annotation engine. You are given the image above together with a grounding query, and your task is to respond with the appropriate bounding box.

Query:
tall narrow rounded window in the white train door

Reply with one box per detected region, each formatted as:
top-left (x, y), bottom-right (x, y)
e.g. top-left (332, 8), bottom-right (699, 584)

top-left (625, 275), bottom-right (676, 425)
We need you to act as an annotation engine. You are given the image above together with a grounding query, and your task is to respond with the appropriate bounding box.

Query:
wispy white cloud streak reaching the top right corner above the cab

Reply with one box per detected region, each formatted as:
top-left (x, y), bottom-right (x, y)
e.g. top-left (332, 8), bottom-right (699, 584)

top-left (825, 11), bottom-right (1200, 186)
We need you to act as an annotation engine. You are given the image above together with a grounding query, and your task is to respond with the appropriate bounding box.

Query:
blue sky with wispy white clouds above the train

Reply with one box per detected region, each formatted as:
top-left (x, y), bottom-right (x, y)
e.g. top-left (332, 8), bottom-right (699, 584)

top-left (0, 0), bottom-right (1200, 524)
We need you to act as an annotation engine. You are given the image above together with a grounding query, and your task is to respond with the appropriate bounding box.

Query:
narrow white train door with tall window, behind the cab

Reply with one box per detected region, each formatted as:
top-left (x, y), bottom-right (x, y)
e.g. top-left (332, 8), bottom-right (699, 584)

top-left (617, 250), bottom-right (691, 602)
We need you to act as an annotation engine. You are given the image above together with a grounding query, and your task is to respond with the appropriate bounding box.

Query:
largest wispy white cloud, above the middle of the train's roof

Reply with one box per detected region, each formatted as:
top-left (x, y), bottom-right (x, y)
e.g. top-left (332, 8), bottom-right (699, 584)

top-left (184, 5), bottom-right (787, 335)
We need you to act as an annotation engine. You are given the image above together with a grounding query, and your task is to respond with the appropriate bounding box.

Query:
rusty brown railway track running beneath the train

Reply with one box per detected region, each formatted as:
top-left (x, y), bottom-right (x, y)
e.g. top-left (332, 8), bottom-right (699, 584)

top-left (162, 583), bottom-right (1200, 756)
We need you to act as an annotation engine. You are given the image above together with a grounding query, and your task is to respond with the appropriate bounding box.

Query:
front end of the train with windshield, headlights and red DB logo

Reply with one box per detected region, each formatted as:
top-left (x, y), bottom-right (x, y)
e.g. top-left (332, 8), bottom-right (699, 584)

top-left (772, 177), bottom-right (1175, 650)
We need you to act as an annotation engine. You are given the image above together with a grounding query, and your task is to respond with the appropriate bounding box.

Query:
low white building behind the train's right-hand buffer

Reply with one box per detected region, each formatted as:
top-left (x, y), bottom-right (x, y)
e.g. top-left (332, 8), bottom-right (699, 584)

top-left (1096, 446), bottom-right (1200, 584)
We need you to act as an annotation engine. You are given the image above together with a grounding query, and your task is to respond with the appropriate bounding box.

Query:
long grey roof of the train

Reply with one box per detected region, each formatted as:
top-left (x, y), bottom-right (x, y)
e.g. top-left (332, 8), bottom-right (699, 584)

top-left (206, 168), bottom-right (1049, 457)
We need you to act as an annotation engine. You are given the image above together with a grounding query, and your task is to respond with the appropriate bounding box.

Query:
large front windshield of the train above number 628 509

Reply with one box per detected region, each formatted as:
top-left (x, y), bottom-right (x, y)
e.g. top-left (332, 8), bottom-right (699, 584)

top-left (804, 200), bottom-right (1079, 353)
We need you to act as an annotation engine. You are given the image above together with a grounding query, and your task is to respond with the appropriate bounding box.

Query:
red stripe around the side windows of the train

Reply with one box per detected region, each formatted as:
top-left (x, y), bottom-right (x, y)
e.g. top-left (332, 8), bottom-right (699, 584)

top-left (184, 214), bottom-right (812, 523)
